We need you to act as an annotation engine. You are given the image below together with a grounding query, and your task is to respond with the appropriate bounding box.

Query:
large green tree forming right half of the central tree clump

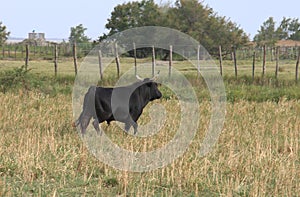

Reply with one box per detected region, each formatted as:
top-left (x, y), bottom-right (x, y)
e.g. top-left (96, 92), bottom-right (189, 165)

top-left (163, 0), bottom-right (249, 54)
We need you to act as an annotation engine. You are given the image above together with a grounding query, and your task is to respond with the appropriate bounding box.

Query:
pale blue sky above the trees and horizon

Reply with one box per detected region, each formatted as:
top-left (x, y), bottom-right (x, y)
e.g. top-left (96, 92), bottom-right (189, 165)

top-left (0, 0), bottom-right (300, 39)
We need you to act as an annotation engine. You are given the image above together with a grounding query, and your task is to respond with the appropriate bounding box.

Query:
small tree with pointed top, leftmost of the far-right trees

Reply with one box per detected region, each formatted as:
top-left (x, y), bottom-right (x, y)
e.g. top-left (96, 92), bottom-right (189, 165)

top-left (254, 17), bottom-right (279, 46)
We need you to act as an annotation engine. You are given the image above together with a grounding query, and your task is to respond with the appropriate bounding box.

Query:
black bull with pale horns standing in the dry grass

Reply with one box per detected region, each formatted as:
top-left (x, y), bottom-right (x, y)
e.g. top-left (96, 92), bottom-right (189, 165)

top-left (76, 78), bottom-right (162, 135)
